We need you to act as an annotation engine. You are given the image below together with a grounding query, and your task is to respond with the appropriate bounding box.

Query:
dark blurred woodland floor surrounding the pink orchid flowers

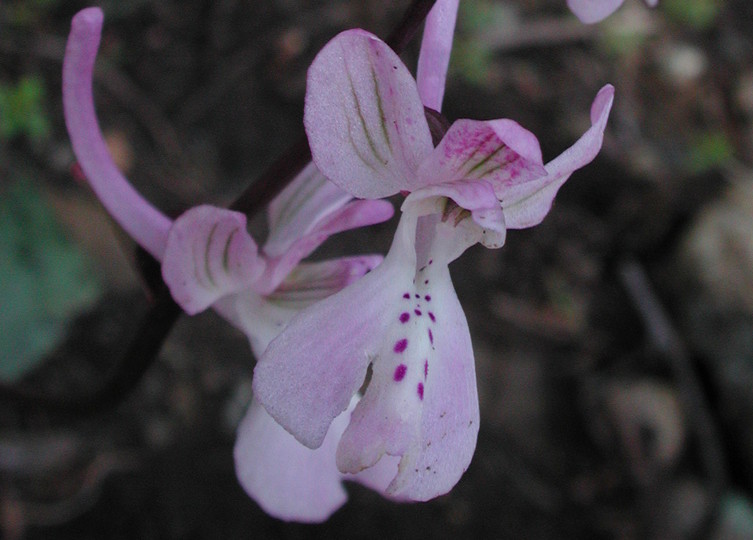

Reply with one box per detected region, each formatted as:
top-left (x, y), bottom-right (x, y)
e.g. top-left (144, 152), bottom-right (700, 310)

top-left (0, 0), bottom-right (753, 540)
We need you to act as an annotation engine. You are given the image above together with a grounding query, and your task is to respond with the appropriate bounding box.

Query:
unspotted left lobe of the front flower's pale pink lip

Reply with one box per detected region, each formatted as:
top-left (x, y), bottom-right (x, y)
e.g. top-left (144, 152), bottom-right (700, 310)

top-left (254, 215), bottom-right (416, 448)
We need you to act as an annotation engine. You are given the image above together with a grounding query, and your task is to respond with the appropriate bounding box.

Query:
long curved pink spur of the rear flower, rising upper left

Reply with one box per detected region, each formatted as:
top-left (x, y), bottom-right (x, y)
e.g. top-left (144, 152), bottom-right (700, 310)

top-left (63, 8), bottom-right (171, 260)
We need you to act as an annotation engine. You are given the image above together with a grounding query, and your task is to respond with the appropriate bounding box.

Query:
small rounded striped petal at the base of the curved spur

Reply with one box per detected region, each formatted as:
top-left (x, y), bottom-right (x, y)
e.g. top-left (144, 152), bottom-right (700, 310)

top-left (162, 205), bottom-right (264, 315)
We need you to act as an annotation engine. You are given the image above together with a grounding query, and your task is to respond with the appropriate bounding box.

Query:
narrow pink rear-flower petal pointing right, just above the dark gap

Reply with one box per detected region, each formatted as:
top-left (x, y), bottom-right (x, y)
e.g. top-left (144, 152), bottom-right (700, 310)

top-left (254, 198), bottom-right (395, 294)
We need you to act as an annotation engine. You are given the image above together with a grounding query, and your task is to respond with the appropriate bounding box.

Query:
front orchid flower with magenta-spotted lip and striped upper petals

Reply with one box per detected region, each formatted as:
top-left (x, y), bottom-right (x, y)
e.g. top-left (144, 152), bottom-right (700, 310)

top-left (253, 30), bottom-right (614, 501)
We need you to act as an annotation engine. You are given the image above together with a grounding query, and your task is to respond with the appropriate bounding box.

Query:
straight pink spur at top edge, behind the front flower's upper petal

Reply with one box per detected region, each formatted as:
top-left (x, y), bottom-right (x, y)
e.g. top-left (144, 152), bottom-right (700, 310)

top-left (416, 0), bottom-right (459, 111)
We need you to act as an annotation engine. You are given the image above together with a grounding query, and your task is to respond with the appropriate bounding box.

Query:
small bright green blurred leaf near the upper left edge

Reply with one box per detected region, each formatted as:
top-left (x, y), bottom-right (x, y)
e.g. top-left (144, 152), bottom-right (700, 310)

top-left (0, 76), bottom-right (50, 142)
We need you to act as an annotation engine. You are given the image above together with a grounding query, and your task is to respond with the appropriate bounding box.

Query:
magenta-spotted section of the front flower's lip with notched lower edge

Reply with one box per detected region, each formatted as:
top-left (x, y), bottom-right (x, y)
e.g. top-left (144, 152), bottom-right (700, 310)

top-left (337, 247), bottom-right (479, 501)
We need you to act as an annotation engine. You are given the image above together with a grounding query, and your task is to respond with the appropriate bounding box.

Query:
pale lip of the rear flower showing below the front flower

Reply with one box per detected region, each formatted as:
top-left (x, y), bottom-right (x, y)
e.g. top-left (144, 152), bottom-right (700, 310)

top-left (234, 400), bottom-right (350, 523)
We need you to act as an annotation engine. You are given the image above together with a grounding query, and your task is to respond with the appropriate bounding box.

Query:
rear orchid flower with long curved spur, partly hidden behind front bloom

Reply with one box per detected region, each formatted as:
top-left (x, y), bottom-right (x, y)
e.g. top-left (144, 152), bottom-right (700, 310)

top-left (63, 8), bottom-right (400, 521)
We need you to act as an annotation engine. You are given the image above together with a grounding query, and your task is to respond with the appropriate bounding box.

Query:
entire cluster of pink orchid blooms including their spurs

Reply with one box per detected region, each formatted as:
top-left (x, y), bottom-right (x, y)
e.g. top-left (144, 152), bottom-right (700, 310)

top-left (57, 0), bottom-right (648, 522)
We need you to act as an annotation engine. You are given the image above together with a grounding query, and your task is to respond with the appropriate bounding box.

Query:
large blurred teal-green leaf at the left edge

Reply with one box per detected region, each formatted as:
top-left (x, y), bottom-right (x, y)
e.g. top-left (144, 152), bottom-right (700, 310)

top-left (0, 180), bottom-right (100, 381)
